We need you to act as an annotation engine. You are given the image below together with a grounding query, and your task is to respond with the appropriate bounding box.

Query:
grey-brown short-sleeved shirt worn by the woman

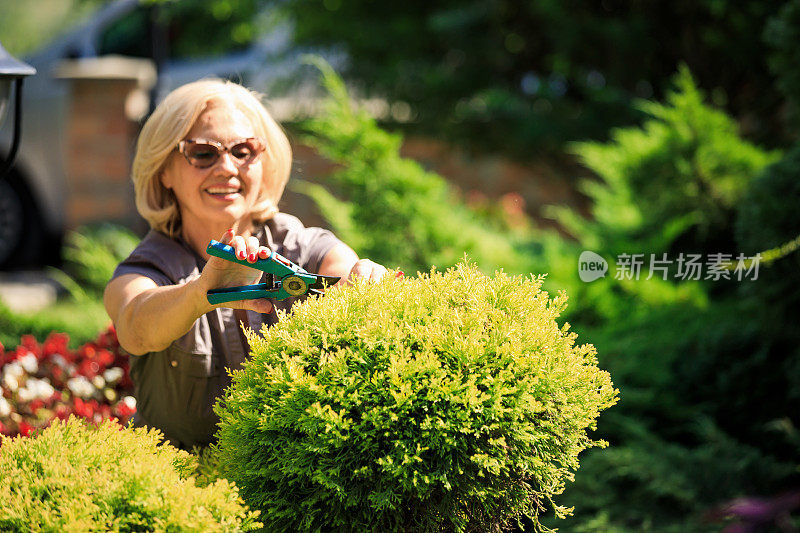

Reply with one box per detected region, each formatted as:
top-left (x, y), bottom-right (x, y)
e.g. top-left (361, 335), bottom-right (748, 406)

top-left (112, 213), bottom-right (341, 449)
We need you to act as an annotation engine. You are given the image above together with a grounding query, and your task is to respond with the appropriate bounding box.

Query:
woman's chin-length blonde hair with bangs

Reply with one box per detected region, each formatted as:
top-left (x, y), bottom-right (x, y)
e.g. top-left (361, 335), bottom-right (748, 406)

top-left (132, 79), bottom-right (292, 237)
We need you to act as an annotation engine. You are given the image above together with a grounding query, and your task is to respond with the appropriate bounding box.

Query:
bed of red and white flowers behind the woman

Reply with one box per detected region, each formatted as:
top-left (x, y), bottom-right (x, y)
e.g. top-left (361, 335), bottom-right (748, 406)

top-left (0, 326), bottom-right (136, 436)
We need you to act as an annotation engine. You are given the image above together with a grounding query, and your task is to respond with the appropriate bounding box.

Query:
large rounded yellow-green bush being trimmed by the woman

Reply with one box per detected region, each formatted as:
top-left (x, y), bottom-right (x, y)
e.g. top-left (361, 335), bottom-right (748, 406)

top-left (217, 264), bottom-right (617, 531)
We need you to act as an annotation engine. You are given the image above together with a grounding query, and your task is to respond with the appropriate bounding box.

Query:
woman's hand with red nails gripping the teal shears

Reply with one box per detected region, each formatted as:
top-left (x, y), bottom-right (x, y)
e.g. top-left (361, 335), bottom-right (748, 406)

top-left (198, 229), bottom-right (272, 313)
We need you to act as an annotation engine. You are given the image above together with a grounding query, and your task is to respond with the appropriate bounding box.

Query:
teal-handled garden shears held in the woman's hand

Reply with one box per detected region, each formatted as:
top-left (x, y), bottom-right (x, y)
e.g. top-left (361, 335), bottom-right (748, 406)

top-left (206, 240), bottom-right (339, 304)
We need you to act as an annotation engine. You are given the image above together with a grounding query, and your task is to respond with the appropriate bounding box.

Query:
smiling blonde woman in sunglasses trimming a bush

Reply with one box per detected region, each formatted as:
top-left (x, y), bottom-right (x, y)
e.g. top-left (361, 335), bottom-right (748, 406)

top-left (104, 80), bottom-right (386, 449)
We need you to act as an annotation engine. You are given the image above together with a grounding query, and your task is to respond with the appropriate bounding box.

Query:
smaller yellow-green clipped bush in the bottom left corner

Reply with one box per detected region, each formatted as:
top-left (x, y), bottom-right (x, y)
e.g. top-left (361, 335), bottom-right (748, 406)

top-left (0, 417), bottom-right (260, 533)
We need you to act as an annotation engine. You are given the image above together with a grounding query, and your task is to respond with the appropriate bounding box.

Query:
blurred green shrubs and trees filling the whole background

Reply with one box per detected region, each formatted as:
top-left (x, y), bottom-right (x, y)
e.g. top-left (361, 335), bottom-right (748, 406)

top-left (0, 0), bottom-right (800, 532)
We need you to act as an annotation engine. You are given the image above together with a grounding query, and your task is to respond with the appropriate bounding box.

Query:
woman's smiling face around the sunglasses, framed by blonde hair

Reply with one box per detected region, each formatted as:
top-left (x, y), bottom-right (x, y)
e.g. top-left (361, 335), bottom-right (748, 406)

top-left (161, 102), bottom-right (266, 234)
